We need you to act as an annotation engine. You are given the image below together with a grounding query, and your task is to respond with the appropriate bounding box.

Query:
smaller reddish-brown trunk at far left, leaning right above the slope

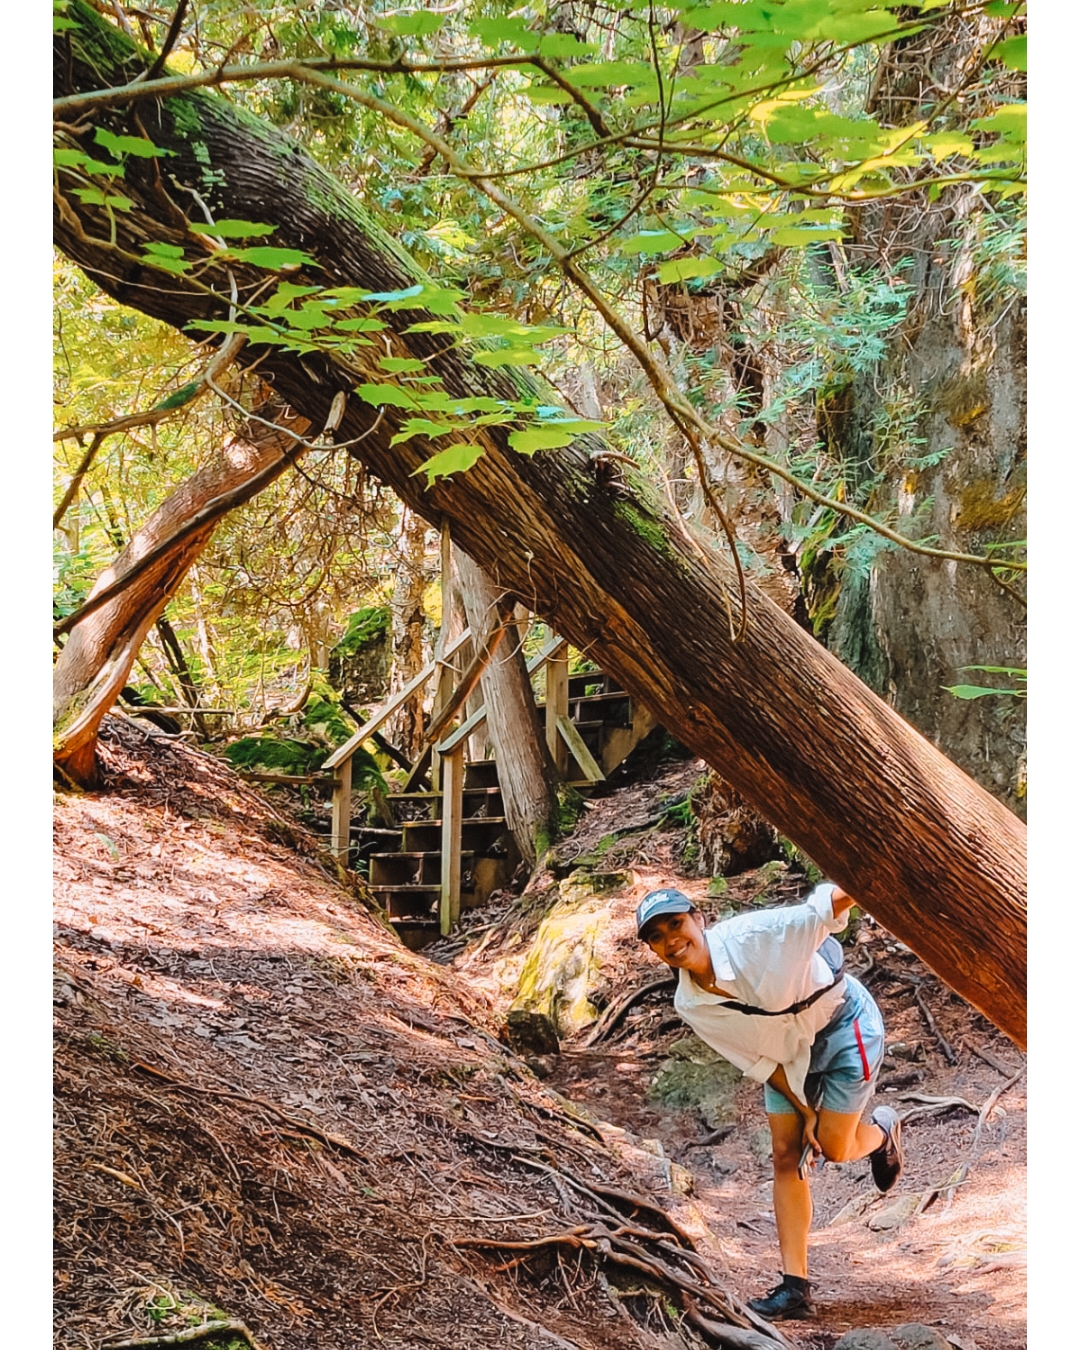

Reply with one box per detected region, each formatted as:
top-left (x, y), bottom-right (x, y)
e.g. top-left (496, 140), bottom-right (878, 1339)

top-left (53, 391), bottom-right (308, 787)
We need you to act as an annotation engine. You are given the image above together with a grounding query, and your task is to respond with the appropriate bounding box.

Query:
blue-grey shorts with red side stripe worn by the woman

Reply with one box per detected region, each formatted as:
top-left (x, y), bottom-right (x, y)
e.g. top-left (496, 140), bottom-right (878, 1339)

top-left (764, 975), bottom-right (886, 1115)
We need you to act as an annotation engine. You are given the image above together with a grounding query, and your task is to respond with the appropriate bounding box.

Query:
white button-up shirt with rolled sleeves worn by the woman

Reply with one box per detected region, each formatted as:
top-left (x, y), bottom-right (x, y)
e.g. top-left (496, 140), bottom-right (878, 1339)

top-left (675, 882), bottom-right (848, 1102)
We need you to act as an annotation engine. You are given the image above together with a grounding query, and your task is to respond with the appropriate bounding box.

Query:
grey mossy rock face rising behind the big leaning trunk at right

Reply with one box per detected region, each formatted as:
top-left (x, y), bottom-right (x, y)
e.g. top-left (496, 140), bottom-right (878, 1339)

top-left (810, 170), bottom-right (1027, 815)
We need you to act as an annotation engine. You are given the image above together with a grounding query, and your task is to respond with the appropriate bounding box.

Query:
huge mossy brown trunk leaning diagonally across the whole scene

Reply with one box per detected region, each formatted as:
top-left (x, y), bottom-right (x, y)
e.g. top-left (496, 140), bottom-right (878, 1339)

top-left (55, 3), bottom-right (1026, 1044)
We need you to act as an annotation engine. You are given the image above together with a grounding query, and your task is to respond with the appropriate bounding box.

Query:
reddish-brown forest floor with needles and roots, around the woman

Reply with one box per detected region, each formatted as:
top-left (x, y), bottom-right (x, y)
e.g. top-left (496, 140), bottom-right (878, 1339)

top-left (54, 721), bottom-right (1026, 1350)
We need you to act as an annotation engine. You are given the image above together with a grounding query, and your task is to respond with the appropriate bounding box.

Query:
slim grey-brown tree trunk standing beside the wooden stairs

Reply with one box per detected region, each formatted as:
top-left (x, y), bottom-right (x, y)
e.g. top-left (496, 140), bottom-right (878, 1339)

top-left (455, 549), bottom-right (556, 867)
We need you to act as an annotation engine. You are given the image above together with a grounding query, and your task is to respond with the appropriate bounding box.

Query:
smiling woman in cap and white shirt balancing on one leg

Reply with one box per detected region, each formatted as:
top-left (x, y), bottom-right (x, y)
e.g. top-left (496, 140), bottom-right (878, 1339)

top-left (637, 882), bottom-right (903, 1319)
